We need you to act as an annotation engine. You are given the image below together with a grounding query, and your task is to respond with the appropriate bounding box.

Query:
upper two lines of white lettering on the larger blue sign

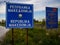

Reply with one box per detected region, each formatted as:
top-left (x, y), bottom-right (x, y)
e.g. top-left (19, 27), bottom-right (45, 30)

top-left (8, 5), bottom-right (32, 13)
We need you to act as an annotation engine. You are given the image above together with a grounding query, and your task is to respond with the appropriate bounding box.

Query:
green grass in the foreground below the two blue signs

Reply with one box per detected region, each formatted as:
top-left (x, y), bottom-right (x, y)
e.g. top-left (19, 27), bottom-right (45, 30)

top-left (4, 28), bottom-right (60, 45)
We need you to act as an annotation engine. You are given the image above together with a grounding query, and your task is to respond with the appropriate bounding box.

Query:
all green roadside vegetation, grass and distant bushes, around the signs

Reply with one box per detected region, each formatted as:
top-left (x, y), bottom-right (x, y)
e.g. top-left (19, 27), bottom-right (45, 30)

top-left (0, 19), bottom-right (60, 45)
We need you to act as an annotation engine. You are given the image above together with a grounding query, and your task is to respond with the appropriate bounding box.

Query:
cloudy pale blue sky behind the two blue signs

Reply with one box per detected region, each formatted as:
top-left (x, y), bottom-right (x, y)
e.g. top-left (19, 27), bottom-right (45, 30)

top-left (0, 0), bottom-right (60, 21)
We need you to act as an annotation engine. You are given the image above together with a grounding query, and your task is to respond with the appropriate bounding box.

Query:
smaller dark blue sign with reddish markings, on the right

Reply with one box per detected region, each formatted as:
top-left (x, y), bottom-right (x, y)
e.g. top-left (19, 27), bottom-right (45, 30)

top-left (46, 7), bottom-right (58, 28)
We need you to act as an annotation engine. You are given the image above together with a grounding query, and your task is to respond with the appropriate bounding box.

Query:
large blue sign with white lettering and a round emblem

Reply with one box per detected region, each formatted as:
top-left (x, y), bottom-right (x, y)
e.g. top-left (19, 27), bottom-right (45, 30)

top-left (6, 3), bottom-right (33, 28)
